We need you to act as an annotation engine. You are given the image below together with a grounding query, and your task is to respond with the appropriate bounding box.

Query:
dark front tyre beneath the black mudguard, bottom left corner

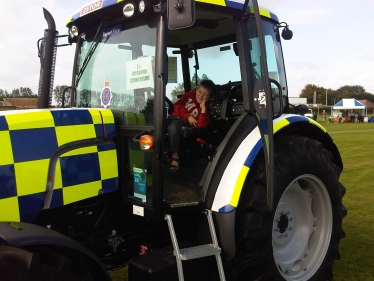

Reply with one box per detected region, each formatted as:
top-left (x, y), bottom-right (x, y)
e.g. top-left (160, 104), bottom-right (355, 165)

top-left (0, 245), bottom-right (98, 281)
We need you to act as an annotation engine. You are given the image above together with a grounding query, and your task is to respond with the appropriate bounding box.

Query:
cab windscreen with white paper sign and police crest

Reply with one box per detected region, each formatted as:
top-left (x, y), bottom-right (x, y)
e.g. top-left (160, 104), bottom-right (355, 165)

top-left (76, 16), bottom-right (156, 113)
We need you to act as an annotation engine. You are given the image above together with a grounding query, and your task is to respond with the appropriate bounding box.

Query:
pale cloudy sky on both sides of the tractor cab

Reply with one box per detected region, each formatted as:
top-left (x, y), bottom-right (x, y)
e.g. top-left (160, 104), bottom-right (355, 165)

top-left (0, 0), bottom-right (374, 97)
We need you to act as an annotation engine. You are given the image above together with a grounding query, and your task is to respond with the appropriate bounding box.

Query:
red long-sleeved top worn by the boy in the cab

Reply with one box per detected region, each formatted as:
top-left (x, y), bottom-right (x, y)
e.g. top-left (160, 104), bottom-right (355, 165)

top-left (171, 91), bottom-right (210, 128)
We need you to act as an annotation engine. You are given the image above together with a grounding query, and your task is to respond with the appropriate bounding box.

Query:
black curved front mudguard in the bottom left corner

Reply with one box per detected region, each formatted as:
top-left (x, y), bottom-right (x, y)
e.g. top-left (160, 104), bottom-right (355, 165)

top-left (0, 222), bottom-right (111, 280)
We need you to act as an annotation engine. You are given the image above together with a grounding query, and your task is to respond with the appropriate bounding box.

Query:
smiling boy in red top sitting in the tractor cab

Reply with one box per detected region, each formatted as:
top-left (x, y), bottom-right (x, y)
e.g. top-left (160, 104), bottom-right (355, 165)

top-left (168, 80), bottom-right (215, 172)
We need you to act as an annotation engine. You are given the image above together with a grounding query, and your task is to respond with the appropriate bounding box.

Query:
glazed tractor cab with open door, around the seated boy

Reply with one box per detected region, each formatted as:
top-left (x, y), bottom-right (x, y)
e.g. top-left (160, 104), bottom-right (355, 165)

top-left (63, 1), bottom-right (288, 218)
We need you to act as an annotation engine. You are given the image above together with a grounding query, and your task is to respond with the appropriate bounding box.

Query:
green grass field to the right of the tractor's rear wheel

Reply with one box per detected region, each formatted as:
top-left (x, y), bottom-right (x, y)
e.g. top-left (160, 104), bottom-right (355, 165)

top-left (111, 120), bottom-right (374, 281)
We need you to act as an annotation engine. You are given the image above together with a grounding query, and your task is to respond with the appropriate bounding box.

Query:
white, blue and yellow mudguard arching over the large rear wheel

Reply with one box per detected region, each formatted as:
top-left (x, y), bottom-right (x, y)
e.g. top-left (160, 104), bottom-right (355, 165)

top-left (206, 114), bottom-right (342, 259)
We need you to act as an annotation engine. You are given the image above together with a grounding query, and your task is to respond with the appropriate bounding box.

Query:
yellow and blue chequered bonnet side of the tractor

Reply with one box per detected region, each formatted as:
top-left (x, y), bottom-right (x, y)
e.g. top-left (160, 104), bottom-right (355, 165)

top-left (0, 109), bottom-right (118, 221)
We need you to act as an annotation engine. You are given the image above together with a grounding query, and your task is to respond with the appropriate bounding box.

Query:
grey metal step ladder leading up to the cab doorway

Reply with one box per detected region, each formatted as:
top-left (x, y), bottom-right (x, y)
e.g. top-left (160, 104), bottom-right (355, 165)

top-left (165, 210), bottom-right (226, 281)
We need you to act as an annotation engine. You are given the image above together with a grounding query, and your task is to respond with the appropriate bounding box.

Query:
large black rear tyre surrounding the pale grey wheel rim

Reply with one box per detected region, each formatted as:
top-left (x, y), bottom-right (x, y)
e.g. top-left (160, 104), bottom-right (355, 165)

top-left (229, 136), bottom-right (346, 281)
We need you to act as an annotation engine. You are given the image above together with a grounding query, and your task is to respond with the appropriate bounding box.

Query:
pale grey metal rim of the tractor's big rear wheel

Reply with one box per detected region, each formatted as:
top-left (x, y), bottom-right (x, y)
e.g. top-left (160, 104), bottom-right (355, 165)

top-left (272, 175), bottom-right (332, 281)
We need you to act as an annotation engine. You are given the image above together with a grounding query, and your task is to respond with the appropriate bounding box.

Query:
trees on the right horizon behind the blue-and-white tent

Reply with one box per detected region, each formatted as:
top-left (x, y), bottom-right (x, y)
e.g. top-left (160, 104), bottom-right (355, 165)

top-left (299, 84), bottom-right (374, 105)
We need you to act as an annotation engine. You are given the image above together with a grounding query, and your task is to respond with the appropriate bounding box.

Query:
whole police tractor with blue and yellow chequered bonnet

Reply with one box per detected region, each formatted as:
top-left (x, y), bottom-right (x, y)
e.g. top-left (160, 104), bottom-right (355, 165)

top-left (0, 0), bottom-right (346, 281)
